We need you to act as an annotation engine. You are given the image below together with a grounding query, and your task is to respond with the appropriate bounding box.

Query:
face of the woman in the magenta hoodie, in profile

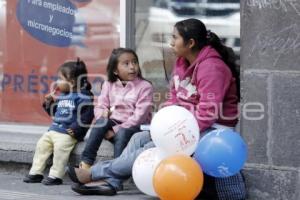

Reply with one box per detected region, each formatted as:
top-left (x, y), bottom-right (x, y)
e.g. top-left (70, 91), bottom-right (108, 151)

top-left (170, 27), bottom-right (190, 57)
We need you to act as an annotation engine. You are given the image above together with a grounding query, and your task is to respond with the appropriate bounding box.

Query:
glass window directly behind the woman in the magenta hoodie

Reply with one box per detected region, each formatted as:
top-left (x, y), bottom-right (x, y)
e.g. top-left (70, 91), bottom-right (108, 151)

top-left (135, 0), bottom-right (240, 109)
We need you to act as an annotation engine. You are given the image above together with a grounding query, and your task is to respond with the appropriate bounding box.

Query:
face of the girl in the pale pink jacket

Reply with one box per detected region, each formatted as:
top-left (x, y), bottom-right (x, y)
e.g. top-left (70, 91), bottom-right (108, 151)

top-left (114, 53), bottom-right (140, 81)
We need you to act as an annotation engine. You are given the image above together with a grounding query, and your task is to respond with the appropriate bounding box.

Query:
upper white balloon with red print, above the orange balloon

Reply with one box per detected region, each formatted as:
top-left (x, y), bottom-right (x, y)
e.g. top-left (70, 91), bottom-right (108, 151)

top-left (150, 106), bottom-right (200, 155)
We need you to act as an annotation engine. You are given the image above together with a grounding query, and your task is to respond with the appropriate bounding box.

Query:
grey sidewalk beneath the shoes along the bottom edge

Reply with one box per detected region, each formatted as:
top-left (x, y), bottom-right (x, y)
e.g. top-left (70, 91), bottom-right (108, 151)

top-left (0, 172), bottom-right (156, 200)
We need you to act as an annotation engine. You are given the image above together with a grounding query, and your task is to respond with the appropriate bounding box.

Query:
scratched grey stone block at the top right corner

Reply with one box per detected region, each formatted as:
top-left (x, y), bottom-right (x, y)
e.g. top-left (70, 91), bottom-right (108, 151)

top-left (241, 0), bottom-right (300, 71)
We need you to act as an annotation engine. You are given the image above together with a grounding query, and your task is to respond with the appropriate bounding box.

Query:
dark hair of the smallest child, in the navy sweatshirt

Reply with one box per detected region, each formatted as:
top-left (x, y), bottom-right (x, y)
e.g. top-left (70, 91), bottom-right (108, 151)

top-left (58, 58), bottom-right (92, 91)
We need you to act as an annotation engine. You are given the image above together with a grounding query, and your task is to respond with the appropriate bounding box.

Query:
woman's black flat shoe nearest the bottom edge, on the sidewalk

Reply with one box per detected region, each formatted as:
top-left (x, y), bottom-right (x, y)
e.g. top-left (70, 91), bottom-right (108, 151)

top-left (71, 183), bottom-right (117, 196)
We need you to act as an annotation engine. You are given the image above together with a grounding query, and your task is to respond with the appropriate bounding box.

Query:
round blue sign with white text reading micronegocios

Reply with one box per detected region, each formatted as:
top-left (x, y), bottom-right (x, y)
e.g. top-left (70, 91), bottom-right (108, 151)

top-left (17, 0), bottom-right (77, 47)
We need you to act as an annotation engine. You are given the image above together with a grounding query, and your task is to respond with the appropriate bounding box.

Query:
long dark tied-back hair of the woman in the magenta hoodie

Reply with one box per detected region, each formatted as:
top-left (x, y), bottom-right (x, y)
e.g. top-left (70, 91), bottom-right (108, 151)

top-left (175, 18), bottom-right (240, 99)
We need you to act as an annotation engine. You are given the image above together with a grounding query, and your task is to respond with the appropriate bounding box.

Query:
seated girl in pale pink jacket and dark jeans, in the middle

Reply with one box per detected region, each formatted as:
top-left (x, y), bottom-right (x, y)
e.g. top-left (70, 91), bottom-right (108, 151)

top-left (80, 48), bottom-right (153, 168)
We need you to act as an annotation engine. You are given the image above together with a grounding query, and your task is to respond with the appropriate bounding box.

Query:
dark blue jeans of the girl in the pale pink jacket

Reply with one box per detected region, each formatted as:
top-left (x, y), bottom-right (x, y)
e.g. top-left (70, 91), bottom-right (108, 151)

top-left (81, 118), bottom-right (140, 165)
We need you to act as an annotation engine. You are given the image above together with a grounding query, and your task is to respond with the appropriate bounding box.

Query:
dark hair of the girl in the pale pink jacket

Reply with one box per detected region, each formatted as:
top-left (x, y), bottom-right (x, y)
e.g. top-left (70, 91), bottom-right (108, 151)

top-left (106, 48), bottom-right (144, 82)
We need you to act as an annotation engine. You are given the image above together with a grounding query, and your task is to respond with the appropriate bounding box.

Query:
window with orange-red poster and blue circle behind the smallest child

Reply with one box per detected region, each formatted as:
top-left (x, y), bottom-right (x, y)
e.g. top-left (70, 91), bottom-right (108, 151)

top-left (0, 0), bottom-right (120, 124)
